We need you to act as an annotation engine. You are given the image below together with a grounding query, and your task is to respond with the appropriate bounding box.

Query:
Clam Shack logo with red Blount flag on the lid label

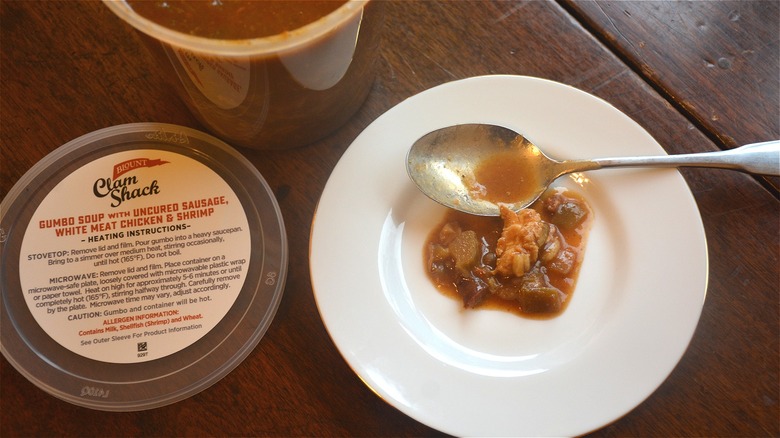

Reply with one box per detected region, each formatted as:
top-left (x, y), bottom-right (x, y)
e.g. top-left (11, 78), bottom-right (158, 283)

top-left (92, 158), bottom-right (169, 207)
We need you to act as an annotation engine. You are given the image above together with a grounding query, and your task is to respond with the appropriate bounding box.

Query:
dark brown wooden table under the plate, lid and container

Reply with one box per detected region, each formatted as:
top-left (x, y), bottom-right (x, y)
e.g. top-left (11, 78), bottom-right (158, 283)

top-left (0, 0), bottom-right (780, 436)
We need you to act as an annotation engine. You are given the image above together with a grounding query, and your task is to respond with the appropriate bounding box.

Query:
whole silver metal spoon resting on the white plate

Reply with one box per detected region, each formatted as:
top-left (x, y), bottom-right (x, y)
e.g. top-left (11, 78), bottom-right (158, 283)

top-left (406, 124), bottom-right (780, 216)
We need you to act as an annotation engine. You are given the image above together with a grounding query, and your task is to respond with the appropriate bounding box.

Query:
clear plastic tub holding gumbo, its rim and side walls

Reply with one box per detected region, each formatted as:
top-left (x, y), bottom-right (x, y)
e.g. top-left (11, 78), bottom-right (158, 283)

top-left (104, 0), bottom-right (384, 149)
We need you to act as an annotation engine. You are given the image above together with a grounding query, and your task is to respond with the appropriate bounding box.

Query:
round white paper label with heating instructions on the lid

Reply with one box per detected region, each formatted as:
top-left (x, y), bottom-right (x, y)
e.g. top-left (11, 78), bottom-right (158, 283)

top-left (19, 150), bottom-right (251, 363)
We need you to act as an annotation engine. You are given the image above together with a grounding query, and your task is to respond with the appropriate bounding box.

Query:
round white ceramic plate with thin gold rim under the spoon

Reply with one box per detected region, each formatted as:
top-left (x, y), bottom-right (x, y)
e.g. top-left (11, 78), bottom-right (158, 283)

top-left (310, 76), bottom-right (707, 436)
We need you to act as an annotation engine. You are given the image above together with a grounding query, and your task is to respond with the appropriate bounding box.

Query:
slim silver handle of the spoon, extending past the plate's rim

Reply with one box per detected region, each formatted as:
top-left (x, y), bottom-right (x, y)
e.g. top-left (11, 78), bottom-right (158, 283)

top-left (582, 140), bottom-right (780, 176)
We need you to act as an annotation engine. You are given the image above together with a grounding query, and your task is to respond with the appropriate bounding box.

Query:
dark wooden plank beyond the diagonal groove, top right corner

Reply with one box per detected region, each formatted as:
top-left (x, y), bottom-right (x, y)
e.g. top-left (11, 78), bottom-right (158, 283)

top-left (565, 0), bottom-right (780, 195)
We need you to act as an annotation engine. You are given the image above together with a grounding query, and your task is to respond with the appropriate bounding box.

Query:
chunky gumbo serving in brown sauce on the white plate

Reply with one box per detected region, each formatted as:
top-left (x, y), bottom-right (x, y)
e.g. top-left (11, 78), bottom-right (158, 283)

top-left (425, 188), bottom-right (593, 317)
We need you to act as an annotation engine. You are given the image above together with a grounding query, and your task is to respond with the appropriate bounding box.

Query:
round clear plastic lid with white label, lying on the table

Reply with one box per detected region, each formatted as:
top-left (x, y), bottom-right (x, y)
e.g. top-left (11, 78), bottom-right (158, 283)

top-left (0, 123), bottom-right (288, 411)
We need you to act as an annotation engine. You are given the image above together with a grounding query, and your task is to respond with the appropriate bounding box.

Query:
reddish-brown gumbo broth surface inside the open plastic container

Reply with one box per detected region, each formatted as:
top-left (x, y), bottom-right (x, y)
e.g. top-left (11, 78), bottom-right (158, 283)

top-left (127, 0), bottom-right (346, 40)
